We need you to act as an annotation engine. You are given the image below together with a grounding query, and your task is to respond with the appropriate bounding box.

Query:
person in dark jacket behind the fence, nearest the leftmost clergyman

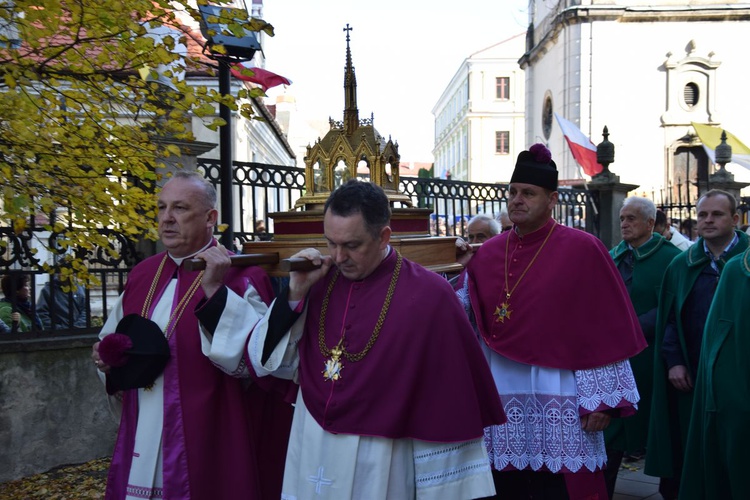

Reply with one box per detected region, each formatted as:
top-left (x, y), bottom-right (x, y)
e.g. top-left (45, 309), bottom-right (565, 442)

top-left (36, 275), bottom-right (87, 330)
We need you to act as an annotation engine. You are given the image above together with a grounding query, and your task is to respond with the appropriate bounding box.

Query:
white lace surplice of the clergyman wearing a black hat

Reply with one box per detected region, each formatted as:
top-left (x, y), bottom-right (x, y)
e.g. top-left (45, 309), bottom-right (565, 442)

top-left (482, 344), bottom-right (639, 472)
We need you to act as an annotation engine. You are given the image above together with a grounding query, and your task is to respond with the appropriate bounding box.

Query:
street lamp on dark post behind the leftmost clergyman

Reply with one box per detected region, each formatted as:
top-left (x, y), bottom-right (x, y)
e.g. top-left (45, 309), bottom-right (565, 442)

top-left (198, 5), bottom-right (261, 249)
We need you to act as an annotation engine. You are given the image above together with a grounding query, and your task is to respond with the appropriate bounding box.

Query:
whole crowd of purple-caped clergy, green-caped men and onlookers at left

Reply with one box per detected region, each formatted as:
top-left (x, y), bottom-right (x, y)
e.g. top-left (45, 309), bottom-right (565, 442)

top-left (7, 144), bottom-right (750, 500)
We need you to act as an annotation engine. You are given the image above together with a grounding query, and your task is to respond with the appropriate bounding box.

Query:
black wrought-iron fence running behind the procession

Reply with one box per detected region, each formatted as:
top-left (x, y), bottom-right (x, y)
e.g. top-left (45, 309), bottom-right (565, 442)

top-left (0, 160), bottom-right (598, 341)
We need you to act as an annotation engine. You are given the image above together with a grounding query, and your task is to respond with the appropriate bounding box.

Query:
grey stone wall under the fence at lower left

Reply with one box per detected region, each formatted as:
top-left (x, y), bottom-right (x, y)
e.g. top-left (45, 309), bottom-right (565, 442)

top-left (0, 334), bottom-right (117, 482)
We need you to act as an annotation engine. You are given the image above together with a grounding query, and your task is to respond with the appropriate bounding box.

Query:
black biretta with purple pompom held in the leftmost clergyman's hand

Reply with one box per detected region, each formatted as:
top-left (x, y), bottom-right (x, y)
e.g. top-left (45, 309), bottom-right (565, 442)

top-left (99, 314), bottom-right (169, 394)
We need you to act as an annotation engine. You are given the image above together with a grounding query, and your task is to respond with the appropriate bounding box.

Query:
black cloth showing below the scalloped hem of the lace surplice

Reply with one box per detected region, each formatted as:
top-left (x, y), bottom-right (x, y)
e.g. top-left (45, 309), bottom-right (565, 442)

top-left (487, 470), bottom-right (568, 500)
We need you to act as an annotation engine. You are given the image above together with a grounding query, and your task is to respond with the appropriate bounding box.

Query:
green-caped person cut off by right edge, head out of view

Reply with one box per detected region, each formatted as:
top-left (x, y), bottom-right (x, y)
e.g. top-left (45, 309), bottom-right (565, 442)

top-left (680, 243), bottom-right (750, 500)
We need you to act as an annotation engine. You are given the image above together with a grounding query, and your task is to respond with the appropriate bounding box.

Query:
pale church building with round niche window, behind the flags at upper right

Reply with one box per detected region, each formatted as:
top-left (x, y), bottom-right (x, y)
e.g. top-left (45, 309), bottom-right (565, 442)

top-left (519, 0), bottom-right (750, 197)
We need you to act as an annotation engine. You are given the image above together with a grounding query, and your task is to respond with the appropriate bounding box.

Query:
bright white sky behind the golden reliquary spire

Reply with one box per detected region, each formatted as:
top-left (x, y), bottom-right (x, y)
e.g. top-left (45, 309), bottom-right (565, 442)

top-left (262, 0), bottom-right (528, 162)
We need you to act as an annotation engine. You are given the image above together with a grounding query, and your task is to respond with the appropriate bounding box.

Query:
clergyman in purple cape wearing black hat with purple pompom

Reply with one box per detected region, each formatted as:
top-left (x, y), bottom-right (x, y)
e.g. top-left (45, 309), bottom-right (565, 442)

top-left (457, 144), bottom-right (646, 499)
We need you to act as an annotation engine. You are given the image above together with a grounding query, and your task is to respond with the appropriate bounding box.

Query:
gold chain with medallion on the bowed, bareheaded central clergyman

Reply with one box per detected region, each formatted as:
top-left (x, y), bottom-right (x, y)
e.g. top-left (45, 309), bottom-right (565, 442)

top-left (318, 249), bottom-right (403, 381)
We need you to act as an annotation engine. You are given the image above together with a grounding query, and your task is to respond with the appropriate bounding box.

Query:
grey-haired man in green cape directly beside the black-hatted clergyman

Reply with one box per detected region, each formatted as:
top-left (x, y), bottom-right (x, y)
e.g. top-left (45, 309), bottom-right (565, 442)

top-left (604, 196), bottom-right (680, 498)
